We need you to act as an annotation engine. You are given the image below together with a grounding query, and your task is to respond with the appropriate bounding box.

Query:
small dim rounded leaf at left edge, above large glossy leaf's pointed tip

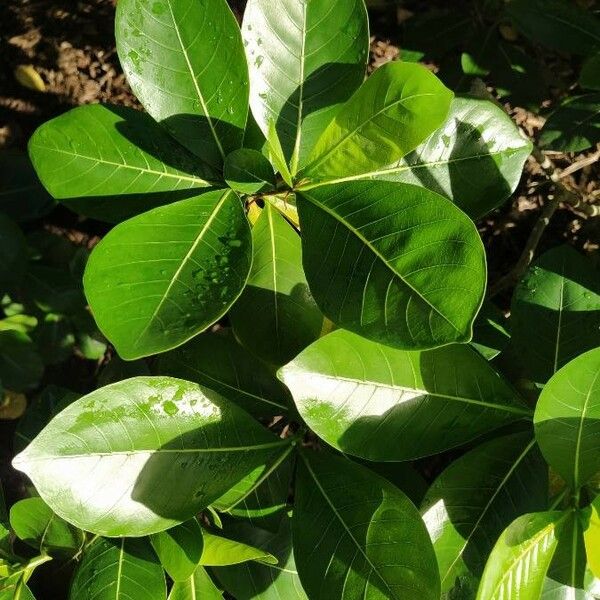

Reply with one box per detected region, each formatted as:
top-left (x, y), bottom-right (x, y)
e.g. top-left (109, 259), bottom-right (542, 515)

top-left (0, 330), bottom-right (44, 392)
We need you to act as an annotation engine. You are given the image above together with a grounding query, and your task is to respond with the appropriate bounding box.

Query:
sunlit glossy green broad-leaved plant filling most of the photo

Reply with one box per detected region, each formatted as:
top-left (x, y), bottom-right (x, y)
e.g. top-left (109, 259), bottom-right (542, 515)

top-left (5, 0), bottom-right (600, 600)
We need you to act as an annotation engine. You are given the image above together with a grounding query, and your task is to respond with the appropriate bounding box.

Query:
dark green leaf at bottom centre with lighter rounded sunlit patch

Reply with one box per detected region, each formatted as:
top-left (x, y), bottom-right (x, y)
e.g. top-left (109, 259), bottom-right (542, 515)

top-left (292, 452), bottom-right (440, 600)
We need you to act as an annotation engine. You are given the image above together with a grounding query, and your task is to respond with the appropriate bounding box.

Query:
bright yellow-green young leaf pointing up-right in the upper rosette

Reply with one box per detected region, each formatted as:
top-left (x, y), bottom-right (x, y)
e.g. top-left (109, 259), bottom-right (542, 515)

top-left (298, 62), bottom-right (453, 181)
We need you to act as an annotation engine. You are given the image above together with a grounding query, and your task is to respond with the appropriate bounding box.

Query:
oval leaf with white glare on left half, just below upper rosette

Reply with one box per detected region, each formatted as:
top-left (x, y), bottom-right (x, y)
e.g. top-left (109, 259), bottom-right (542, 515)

top-left (279, 329), bottom-right (530, 461)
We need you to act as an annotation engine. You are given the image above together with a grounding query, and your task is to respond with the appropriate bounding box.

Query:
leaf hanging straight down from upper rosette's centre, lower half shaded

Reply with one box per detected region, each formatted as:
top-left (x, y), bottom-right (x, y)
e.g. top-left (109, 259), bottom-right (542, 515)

top-left (229, 203), bottom-right (323, 366)
